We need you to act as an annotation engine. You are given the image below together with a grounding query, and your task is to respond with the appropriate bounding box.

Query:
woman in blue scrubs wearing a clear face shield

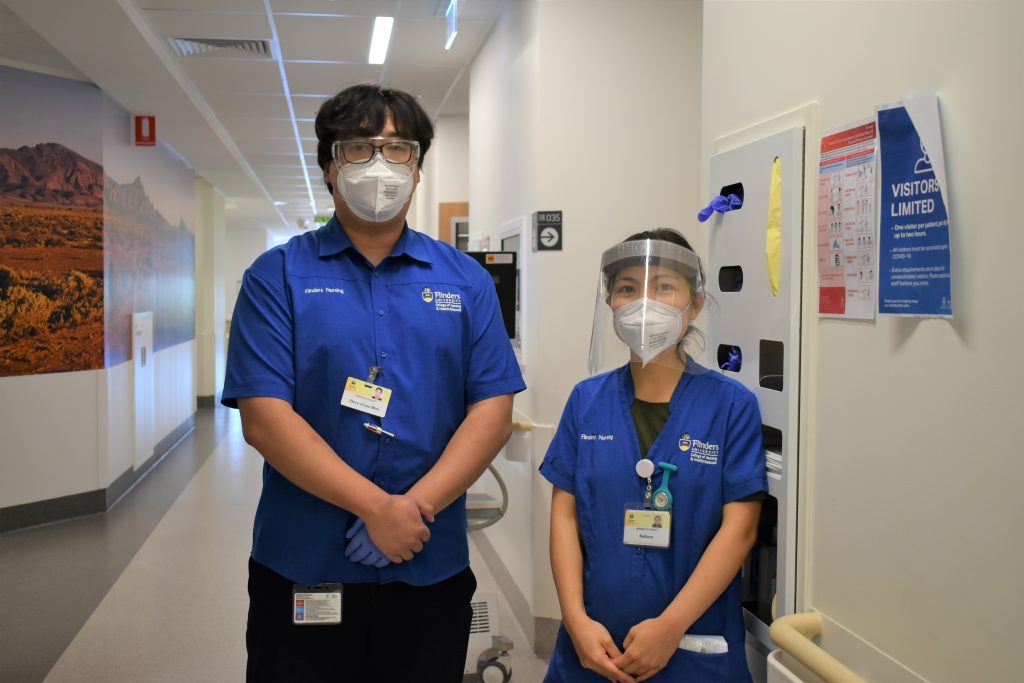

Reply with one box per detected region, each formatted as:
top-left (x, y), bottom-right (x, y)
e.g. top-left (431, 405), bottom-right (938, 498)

top-left (541, 228), bottom-right (768, 683)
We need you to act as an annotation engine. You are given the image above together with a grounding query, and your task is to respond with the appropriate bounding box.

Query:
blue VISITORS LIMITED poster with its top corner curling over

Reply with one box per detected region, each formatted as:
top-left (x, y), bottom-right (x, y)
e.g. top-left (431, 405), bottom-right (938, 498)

top-left (878, 94), bottom-right (953, 317)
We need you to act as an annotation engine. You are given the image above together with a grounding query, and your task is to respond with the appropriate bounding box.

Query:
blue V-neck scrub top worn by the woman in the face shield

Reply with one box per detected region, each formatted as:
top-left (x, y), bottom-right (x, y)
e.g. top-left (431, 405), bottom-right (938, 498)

top-left (541, 357), bottom-right (768, 683)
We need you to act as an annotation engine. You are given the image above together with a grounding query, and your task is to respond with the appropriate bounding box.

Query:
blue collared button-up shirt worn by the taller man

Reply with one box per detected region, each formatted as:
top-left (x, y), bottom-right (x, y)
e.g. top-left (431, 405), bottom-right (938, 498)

top-left (222, 217), bottom-right (525, 586)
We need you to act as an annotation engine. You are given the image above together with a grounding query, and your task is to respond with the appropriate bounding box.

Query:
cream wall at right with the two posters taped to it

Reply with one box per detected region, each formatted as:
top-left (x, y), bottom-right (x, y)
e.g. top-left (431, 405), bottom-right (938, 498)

top-left (701, 1), bottom-right (1024, 683)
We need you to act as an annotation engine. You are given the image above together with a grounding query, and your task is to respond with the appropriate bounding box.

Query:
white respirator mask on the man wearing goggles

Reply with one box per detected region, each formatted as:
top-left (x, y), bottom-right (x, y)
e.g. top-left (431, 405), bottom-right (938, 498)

top-left (338, 155), bottom-right (414, 223)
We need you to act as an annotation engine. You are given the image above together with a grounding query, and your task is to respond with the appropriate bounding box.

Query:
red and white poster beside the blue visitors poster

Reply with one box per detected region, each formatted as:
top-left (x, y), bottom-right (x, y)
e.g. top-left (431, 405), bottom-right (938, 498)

top-left (817, 121), bottom-right (878, 321)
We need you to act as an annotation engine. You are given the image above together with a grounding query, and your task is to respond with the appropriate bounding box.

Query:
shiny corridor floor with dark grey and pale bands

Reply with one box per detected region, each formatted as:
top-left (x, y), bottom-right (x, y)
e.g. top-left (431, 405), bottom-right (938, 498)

top-left (0, 408), bottom-right (547, 682)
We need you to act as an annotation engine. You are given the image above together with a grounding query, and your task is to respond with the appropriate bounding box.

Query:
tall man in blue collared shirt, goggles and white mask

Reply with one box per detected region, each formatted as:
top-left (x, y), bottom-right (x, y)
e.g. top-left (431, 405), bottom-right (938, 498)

top-left (223, 85), bottom-right (525, 683)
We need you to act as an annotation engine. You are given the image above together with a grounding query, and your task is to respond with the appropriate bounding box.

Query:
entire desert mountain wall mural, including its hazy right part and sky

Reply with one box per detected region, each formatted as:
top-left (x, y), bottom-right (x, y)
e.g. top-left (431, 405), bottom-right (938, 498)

top-left (0, 67), bottom-right (196, 377)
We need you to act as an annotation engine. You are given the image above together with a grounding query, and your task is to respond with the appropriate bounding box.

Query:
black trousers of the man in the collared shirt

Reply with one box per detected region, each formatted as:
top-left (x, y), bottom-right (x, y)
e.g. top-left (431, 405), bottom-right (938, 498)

top-left (246, 557), bottom-right (476, 683)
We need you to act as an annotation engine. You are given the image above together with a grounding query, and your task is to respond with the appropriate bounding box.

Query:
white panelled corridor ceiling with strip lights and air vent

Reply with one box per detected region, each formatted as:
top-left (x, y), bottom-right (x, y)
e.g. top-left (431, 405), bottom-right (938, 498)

top-left (0, 0), bottom-right (507, 232)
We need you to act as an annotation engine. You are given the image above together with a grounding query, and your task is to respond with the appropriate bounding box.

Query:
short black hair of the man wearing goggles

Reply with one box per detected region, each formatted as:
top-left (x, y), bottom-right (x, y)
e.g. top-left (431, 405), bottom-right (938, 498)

top-left (313, 83), bottom-right (434, 181)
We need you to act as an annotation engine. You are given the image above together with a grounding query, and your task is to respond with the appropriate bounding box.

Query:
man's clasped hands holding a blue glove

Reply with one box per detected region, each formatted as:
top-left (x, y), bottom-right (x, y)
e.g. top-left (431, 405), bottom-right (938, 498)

top-left (345, 496), bottom-right (434, 567)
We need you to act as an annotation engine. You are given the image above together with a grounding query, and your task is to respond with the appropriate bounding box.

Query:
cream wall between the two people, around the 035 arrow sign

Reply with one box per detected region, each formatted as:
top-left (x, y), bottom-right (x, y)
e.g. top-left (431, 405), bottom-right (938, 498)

top-left (469, 0), bottom-right (700, 617)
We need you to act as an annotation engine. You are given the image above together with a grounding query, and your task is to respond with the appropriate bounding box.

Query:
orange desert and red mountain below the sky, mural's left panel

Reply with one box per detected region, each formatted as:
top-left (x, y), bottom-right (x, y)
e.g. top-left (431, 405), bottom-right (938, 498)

top-left (0, 143), bottom-right (103, 376)
